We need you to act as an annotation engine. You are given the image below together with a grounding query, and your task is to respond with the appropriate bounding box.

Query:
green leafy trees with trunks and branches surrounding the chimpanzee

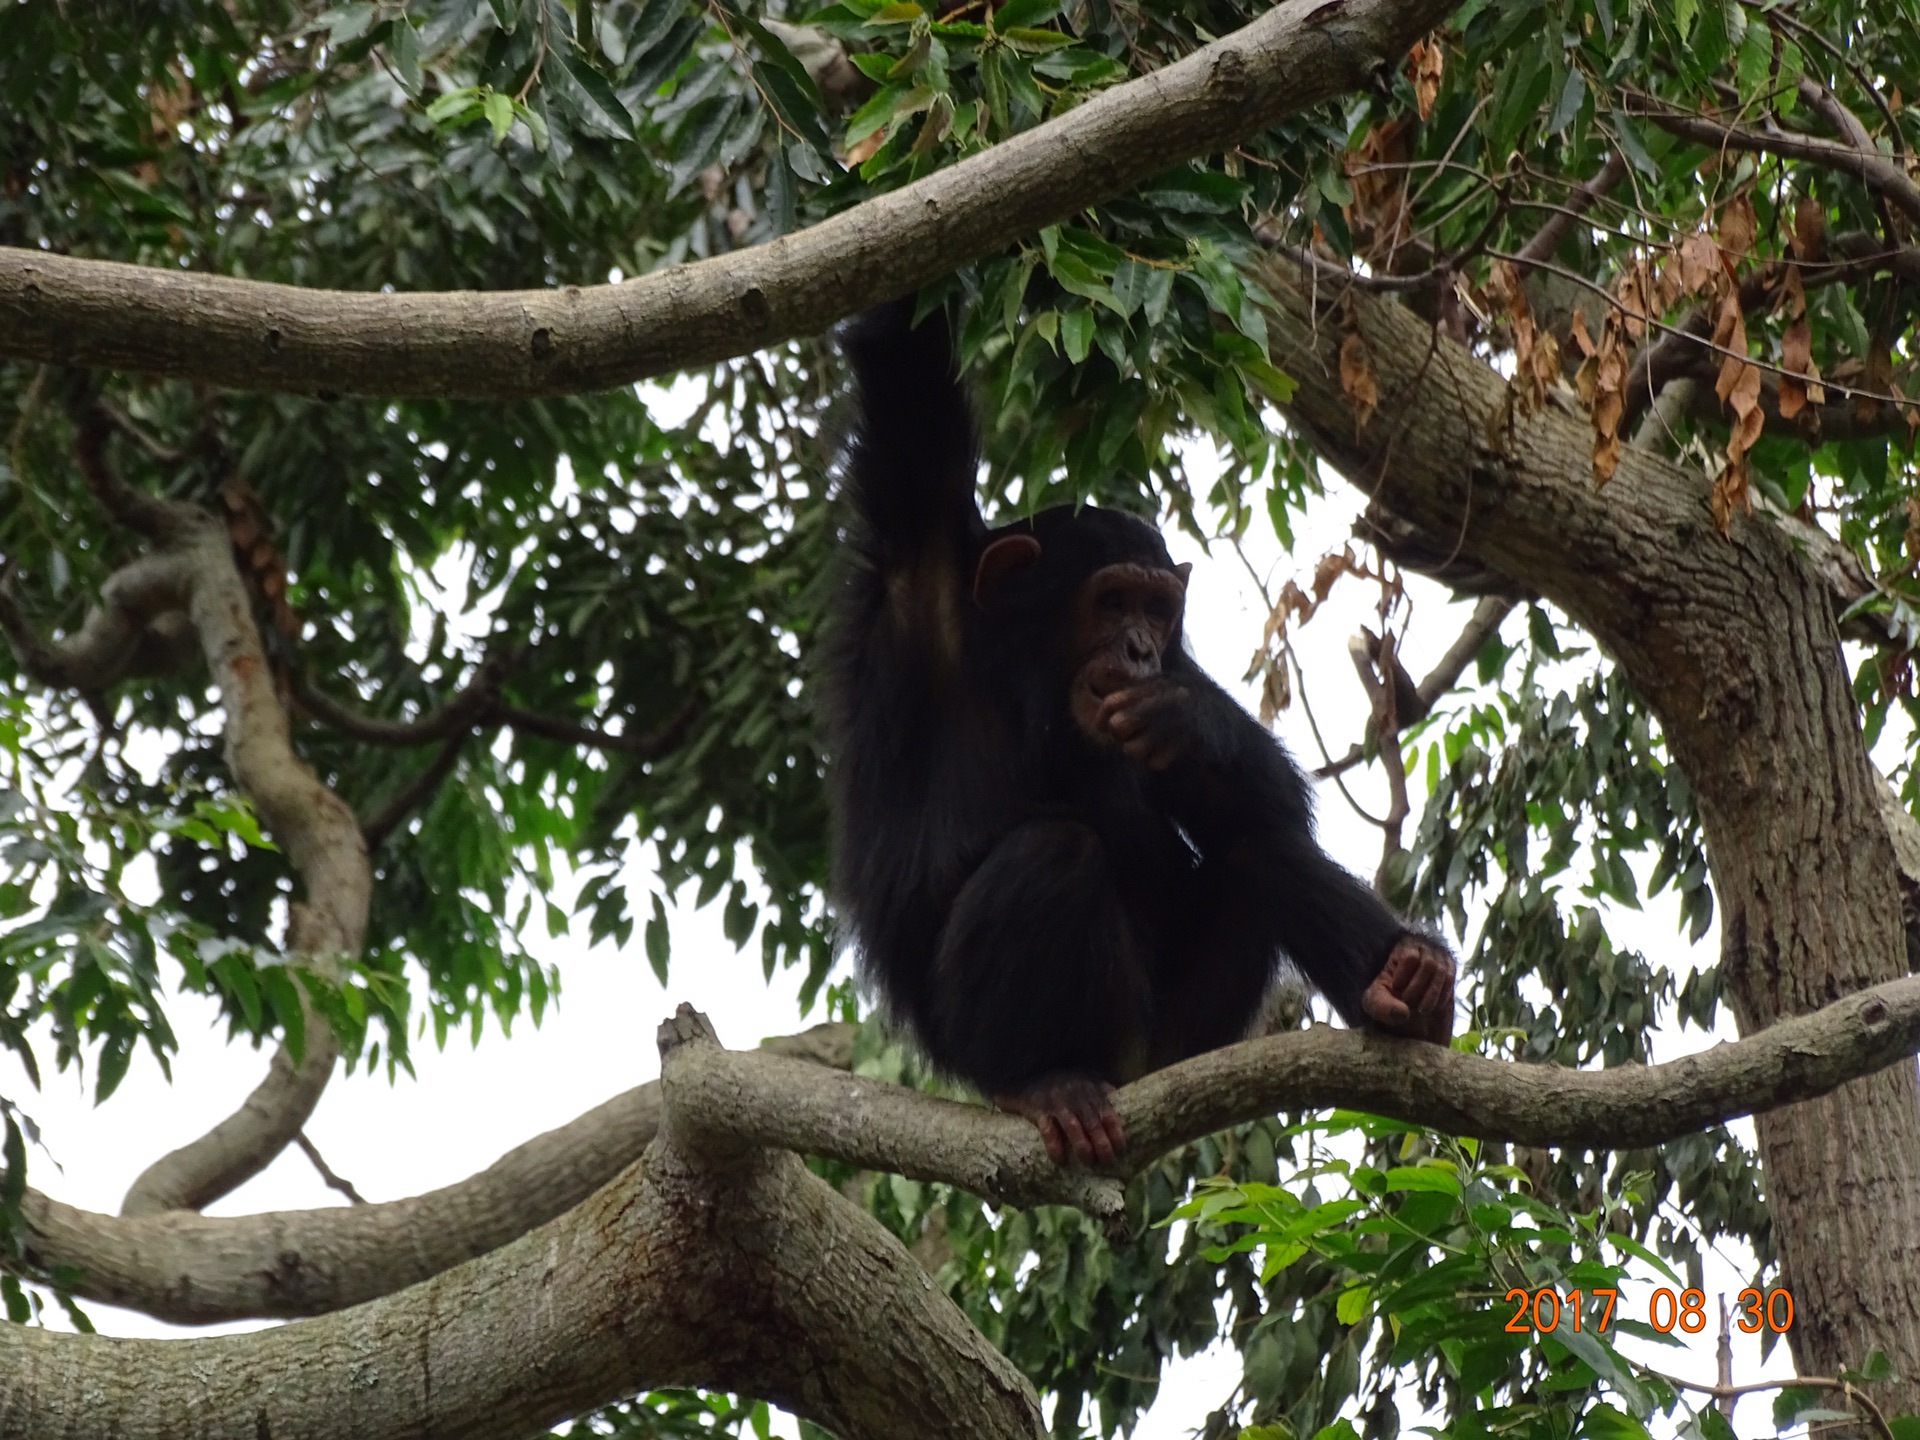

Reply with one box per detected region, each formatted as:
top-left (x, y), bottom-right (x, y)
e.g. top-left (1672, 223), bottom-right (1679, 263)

top-left (0, 0), bottom-right (1920, 1440)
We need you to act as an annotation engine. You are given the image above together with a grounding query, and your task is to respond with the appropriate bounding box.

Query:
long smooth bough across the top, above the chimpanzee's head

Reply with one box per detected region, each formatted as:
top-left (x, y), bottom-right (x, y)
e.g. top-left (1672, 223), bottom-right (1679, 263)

top-left (0, 0), bottom-right (1452, 397)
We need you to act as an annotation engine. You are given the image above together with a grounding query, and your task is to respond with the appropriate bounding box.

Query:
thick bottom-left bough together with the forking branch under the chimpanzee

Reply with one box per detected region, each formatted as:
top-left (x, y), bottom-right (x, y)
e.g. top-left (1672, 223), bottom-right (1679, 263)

top-left (11, 977), bottom-right (1920, 1440)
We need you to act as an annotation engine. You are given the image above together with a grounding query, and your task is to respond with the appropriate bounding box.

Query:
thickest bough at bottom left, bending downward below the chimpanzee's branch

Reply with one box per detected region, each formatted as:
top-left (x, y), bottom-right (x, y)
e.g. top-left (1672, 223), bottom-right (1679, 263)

top-left (0, 1016), bottom-right (1041, 1440)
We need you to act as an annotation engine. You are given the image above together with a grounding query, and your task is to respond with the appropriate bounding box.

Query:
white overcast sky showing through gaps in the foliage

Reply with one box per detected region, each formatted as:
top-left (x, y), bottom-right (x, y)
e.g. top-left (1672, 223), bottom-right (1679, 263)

top-left (0, 437), bottom-right (1786, 1440)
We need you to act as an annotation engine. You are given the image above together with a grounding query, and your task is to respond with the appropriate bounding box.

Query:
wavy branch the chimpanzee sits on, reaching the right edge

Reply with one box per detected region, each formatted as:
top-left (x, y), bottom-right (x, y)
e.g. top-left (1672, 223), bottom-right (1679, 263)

top-left (662, 977), bottom-right (1920, 1223)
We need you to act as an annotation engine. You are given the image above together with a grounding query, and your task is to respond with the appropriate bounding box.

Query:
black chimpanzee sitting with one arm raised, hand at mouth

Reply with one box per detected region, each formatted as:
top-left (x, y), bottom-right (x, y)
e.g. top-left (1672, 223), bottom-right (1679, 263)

top-left (824, 300), bottom-right (1453, 1165)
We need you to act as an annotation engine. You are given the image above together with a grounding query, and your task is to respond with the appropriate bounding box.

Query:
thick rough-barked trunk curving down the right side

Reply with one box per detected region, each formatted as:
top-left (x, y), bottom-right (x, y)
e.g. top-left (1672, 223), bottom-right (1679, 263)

top-left (1273, 269), bottom-right (1920, 1404)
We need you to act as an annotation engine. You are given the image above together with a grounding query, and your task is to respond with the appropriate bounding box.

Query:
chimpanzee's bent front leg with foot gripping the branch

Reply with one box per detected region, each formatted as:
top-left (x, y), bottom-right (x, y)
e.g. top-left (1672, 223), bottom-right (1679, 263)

top-left (922, 820), bottom-right (1150, 1164)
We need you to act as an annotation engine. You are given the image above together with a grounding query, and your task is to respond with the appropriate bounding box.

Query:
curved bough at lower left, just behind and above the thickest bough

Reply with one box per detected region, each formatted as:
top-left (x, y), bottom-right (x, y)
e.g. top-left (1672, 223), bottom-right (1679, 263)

top-left (21, 1023), bottom-right (852, 1325)
